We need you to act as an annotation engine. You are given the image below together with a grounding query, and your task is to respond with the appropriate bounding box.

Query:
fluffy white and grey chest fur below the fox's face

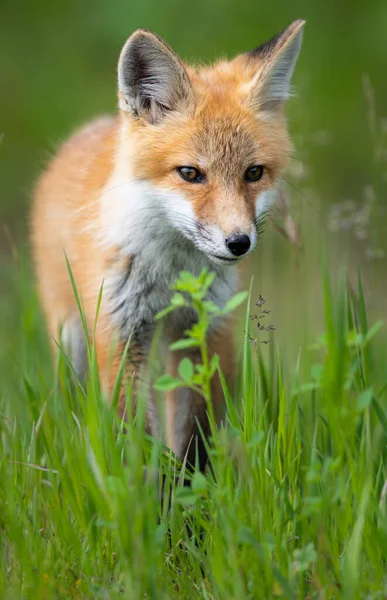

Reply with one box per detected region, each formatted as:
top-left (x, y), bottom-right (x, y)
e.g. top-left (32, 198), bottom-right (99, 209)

top-left (101, 183), bottom-right (237, 342)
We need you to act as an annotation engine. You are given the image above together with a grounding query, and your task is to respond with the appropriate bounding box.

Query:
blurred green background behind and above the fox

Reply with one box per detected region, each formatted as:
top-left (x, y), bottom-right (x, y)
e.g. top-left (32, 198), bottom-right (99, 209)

top-left (0, 0), bottom-right (387, 366)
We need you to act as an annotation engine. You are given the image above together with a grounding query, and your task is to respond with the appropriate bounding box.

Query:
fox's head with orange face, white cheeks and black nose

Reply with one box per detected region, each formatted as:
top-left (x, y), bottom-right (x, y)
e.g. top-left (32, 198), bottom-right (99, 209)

top-left (118, 21), bottom-right (304, 264)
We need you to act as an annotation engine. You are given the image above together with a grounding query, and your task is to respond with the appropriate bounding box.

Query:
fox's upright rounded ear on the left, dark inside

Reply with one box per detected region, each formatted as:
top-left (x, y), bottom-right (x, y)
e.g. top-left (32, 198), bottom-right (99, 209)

top-left (118, 29), bottom-right (194, 123)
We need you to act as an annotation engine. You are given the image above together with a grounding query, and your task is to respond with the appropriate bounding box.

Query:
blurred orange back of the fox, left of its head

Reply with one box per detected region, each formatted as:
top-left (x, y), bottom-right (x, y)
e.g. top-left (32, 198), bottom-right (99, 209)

top-left (31, 117), bottom-right (116, 328)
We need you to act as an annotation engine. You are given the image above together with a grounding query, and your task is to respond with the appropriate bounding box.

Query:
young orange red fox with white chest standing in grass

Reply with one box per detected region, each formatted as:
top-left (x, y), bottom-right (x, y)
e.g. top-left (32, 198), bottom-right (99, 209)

top-left (31, 21), bottom-right (304, 464)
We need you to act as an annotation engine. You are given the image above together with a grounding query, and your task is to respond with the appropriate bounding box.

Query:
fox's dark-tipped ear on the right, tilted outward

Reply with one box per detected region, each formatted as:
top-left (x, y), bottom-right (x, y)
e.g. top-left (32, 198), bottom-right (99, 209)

top-left (245, 20), bottom-right (305, 113)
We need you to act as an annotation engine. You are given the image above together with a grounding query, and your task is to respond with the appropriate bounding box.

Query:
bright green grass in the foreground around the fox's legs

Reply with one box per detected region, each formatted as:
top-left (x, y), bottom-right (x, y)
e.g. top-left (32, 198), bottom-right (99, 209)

top-left (0, 258), bottom-right (387, 600)
